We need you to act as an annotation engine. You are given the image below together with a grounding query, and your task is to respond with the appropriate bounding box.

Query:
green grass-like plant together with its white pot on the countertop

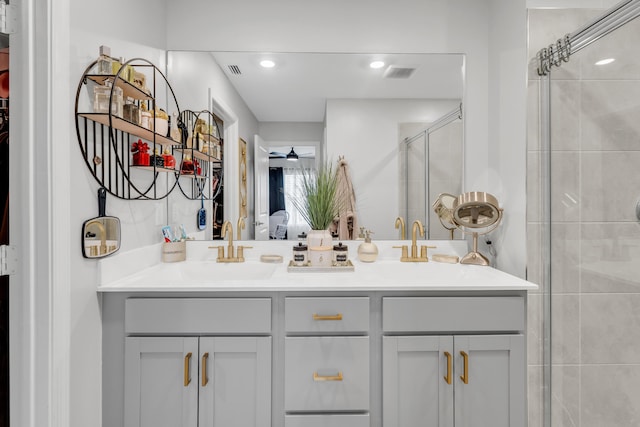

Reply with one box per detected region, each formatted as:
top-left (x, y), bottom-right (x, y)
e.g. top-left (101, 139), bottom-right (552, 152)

top-left (291, 163), bottom-right (342, 266)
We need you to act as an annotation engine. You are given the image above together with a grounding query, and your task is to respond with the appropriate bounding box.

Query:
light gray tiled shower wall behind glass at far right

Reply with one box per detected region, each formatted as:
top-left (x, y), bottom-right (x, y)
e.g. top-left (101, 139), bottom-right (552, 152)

top-left (527, 10), bottom-right (640, 427)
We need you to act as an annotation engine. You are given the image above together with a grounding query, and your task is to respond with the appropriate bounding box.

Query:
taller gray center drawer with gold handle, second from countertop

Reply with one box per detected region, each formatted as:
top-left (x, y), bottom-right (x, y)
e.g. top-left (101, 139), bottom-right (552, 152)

top-left (284, 337), bottom-right (369, 411)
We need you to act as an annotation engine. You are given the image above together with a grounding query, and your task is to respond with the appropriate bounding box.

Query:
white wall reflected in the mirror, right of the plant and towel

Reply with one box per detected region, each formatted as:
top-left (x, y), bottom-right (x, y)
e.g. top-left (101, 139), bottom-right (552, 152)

top-left (326, 99), bottom-right (460, 239)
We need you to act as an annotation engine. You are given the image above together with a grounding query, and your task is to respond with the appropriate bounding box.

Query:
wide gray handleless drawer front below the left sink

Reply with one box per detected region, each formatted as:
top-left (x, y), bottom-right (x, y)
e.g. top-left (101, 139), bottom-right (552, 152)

top-left (125, 298), bottom-right (271, 334)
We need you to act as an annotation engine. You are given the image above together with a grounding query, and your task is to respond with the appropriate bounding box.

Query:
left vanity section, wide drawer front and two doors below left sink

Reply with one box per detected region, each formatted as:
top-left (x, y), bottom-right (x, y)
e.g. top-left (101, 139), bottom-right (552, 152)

top-left (124, 298), bottom-right (272, 427)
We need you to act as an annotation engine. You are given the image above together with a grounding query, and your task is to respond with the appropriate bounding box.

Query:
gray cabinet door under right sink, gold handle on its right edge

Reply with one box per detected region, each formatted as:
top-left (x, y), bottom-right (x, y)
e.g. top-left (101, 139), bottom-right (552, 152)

top-left (382, 336), bottom-right (452, 427)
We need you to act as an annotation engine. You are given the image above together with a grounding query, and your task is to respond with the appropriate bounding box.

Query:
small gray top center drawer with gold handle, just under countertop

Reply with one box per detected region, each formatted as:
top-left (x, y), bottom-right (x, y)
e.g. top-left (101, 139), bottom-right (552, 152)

top-left (284, 297), bottom-right (369, 333)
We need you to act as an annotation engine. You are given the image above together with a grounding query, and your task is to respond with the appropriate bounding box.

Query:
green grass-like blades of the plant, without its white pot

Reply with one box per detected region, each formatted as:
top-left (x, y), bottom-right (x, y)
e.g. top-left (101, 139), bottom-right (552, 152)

top-left (291, 163), bottom-right (342, 230)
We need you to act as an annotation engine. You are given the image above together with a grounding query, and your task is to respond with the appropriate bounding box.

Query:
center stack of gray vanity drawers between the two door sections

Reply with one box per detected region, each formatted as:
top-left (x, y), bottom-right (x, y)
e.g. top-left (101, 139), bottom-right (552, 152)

top-left (284, 297), bottom-right (371, 427)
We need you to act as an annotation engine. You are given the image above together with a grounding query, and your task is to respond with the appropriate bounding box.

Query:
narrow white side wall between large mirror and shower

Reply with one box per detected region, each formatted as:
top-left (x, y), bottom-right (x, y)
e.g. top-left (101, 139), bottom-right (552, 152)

top-left (484, 0), bottom-right (528, 277)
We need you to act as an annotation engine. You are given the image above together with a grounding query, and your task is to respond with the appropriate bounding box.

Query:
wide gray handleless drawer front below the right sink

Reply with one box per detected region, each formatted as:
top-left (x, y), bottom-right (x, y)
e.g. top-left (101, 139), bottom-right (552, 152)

top-left (382, 297), bottom-right (525, 332)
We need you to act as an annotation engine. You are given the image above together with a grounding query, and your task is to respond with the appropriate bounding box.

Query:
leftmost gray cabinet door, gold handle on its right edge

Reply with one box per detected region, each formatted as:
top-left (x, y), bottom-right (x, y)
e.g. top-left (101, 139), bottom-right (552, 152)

top-left (124, 337), bottom-right (198, 427)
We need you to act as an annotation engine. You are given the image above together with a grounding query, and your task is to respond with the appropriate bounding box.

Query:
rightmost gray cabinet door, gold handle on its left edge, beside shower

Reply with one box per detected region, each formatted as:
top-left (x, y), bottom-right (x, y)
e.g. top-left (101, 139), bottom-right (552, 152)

top-left (454, 335), bottom-right (526, 427)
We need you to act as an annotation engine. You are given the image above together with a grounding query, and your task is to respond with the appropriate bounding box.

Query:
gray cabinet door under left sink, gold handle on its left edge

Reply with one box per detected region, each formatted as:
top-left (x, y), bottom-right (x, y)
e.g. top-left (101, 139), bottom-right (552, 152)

top-left (198, 337), bottom-right (271, 427)
